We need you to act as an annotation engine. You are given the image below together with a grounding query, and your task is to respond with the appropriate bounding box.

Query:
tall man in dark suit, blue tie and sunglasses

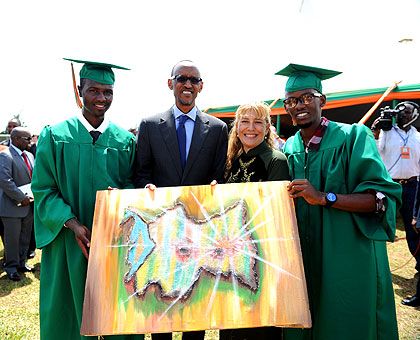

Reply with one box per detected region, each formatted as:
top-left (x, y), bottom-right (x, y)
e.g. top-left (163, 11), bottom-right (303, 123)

top-left (133, 60), bottom-right (228, 340)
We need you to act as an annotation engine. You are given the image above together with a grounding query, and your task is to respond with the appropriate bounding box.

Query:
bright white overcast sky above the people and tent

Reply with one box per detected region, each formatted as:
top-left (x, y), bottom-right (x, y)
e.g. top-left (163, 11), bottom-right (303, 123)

top-left (0, 0), bottom-right (420, 134)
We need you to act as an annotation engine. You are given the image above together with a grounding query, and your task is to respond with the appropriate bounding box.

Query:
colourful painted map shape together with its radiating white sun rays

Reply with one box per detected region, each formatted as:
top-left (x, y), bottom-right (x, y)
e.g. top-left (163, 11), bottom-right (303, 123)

top-left (117, 186), bottom-right (299, 318)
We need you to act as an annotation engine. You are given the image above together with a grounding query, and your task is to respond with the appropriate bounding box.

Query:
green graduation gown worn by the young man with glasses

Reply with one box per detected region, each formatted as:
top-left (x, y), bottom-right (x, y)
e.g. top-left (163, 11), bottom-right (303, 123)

top-left (283, 122), bottom-right (401, 340)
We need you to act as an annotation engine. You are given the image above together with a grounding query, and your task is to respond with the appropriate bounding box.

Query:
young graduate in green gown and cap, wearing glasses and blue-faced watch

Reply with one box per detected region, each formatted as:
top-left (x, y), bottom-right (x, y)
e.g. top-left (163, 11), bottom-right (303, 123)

top-left (277, 64), bottom-right (401, 340)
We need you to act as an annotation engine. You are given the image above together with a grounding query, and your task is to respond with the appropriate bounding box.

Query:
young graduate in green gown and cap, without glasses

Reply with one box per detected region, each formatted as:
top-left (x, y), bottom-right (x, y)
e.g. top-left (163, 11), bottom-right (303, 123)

top-left (32, 60), bottom-right (143, 340)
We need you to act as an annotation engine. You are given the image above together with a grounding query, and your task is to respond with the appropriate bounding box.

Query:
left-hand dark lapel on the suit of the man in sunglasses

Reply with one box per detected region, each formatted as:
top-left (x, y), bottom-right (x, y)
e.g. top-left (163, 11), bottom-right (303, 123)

top-left (159, 108), bottom-right (182, 178)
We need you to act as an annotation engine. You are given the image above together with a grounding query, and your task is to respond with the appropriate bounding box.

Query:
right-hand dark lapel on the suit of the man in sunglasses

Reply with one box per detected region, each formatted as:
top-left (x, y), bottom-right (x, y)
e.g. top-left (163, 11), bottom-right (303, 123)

top-left (181, 109), bottom-right (210, 184)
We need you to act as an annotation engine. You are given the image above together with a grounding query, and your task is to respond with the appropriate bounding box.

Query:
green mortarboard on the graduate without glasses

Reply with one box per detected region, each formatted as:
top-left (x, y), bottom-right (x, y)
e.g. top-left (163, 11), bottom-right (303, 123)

top-left (63, 58), bottom-right (129, 85)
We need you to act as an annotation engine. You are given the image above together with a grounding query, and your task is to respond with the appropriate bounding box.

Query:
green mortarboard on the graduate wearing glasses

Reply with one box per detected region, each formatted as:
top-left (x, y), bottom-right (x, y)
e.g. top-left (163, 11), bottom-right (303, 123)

top-left (276, 64), bottom-right (342, 93)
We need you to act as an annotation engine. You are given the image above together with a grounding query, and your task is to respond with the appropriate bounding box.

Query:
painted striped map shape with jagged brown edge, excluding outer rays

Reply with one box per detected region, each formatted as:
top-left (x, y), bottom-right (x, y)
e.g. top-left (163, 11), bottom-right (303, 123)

top-left (122, 198), bottom-right (259, 299)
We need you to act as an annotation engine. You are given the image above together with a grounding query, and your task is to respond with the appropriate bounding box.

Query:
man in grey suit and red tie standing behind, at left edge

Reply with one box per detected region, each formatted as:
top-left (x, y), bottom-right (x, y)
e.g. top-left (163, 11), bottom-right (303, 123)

top-left (0, 127), bottom-right (34, 281)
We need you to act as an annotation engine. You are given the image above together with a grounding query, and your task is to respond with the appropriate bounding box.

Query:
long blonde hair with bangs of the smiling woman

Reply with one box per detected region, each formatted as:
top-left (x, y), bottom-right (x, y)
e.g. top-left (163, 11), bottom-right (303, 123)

top-left (225, 102), bottom-right (275, 177)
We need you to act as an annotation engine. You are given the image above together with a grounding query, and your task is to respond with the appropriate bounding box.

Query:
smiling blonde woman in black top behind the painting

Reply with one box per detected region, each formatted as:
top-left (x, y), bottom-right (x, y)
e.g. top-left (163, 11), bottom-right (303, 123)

top-left (220, 103), bottom-right (290, 340)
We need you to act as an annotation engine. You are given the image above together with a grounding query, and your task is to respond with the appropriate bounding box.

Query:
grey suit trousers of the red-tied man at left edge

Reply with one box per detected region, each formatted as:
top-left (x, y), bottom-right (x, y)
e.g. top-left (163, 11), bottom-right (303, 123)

top-left (1, 209), bottom-right (34, 274)
